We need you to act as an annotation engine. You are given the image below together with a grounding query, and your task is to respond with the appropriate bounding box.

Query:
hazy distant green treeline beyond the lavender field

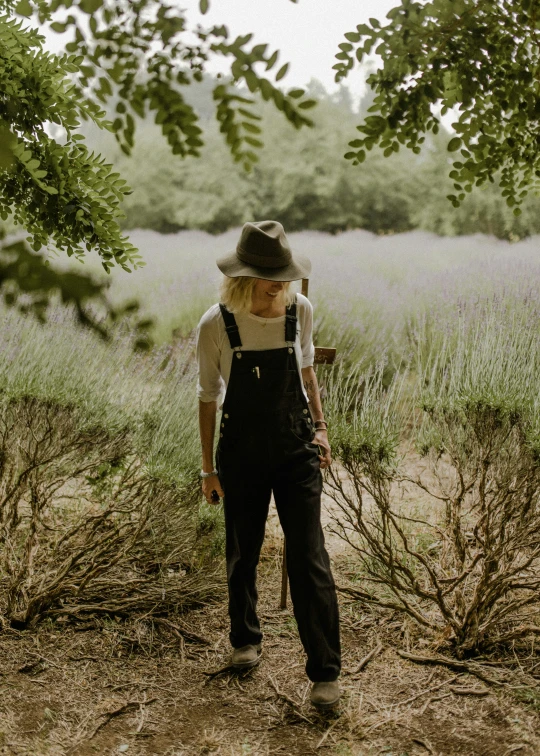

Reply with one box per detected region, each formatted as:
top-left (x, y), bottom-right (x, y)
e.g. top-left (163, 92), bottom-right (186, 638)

top-left (9, 81), bottom-right (540, 239)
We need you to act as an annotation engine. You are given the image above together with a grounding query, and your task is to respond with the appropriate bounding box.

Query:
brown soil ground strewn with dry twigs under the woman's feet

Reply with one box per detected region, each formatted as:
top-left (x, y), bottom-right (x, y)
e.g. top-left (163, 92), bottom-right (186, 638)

top-left (0, 500), bottom-right (540, 756)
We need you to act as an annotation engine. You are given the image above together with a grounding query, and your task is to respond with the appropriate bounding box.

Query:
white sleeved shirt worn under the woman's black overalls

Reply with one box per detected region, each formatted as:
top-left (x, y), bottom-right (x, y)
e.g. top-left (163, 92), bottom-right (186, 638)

top-left (197, 294), bottom-right (315, 407)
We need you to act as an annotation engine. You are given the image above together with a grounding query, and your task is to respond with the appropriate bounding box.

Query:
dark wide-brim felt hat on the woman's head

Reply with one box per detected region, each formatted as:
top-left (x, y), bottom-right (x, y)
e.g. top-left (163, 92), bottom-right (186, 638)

top-left (216, 221), bottom-right (311, 281)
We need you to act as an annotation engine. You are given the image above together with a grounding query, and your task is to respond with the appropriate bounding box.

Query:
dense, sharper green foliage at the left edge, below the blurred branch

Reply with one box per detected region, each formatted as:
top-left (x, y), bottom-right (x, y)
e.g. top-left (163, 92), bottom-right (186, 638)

top-left (0, 16), bottom-right (140, 270)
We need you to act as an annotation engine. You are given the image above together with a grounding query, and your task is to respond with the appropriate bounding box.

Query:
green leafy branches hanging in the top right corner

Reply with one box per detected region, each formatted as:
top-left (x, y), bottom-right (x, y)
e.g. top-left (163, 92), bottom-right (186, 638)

top-left (334, 0), bottom-right (540, 215)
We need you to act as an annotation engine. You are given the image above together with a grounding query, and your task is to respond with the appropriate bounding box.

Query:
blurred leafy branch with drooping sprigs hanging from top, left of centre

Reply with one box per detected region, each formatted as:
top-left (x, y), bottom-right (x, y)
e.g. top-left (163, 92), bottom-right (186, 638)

top-left (7, 0), bottom-right (316, 170)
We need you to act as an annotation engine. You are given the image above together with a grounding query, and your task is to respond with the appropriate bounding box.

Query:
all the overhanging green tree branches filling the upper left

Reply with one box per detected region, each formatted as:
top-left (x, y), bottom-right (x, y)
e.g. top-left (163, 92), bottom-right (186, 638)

top-left (0, 0), bottom-right (315, 332)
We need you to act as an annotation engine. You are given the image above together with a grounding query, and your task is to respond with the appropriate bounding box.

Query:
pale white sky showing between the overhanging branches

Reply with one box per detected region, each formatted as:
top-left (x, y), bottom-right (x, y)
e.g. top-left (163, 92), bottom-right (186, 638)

top-left (179, 0), bottom-right (398, 99)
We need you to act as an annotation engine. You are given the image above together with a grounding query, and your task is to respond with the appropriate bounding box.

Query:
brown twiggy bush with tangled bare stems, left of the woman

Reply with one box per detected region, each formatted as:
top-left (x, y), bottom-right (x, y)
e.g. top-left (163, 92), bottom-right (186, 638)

top-left (0, 398), bottom-right (219, 626)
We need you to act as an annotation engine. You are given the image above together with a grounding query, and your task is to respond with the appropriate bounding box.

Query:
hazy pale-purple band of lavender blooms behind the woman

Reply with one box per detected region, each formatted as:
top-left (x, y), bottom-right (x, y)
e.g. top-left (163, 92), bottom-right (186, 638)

top-left (76, 229), bottom-right (540, 360)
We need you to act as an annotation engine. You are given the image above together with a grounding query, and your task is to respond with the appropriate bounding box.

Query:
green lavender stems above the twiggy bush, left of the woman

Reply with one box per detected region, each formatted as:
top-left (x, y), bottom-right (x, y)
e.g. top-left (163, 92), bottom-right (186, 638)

top-left (0, 302), bottom-right (199, 486)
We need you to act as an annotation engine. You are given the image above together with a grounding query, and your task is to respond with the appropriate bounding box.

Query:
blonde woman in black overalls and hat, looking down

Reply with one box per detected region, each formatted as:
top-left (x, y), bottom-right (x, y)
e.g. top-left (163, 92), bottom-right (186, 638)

top-left (197, 221), bottom-right (340, 708)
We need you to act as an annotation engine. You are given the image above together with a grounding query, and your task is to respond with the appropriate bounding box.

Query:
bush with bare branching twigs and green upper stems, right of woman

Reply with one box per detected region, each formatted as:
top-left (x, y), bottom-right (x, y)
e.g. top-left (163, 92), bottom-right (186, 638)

top-left (327, 306), bottom-right (540, 656)
